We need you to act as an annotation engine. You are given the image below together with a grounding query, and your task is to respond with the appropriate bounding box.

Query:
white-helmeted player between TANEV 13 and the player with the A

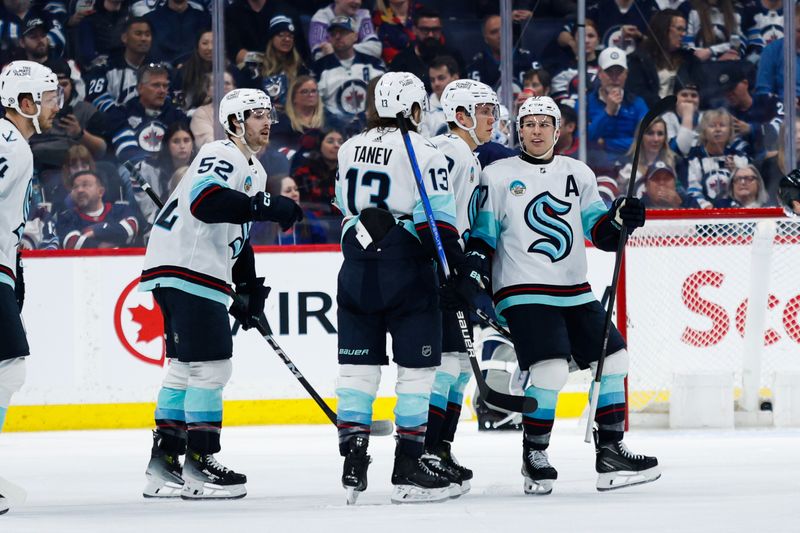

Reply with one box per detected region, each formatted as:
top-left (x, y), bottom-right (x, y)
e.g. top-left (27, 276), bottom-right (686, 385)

top-left (425, 80), bottom-right (500, 494)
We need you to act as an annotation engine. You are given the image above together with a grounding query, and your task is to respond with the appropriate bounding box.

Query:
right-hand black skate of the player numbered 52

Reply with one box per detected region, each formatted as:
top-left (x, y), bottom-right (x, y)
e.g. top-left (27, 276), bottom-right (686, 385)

top-left (181, 450), bottom-right (247, 500)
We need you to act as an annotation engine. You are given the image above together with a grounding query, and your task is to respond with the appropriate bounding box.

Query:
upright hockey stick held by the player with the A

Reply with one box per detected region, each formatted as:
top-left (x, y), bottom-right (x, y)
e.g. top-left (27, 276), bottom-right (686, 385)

top-left (583, 95), bottom-right (676, 443)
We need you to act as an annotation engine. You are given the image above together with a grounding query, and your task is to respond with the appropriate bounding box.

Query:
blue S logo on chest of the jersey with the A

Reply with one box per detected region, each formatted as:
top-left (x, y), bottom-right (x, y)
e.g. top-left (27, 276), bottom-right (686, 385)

top-left (525, 192), bottom-right (573, 263)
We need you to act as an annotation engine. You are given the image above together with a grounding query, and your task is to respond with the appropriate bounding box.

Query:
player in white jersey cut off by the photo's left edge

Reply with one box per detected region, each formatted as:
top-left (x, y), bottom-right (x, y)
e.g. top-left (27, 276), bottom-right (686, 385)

top-left (0, 61), bottom-right (63, 514)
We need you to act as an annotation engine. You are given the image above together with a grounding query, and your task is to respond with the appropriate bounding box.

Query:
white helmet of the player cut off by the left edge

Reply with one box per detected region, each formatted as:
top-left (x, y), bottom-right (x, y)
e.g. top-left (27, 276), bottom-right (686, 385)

top-left (0, 61), bottom-right (64, 133)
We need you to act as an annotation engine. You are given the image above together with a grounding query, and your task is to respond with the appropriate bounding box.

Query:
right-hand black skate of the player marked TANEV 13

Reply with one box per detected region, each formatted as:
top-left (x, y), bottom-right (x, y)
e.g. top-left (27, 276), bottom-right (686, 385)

top-left (392, 452), bottom-right (450, 503)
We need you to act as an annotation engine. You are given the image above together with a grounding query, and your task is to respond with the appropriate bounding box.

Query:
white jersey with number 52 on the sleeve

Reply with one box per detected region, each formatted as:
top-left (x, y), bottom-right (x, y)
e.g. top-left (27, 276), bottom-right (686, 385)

top-left (139, 141), bottom-right (267, 305)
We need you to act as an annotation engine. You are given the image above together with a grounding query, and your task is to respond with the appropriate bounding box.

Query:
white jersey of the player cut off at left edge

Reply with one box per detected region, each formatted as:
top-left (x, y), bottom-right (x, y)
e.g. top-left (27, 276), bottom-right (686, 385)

top-left (0, 118), bottom-right (33, 288)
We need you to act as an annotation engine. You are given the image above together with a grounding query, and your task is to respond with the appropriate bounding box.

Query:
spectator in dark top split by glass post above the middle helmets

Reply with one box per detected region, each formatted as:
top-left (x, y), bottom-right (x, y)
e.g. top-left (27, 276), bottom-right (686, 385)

top-left (467, 15), bottom-right (538, 88)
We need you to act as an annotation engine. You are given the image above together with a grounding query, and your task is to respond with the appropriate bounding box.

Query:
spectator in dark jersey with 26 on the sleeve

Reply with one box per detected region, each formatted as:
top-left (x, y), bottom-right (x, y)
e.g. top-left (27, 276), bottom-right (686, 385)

top-left (86, 18), bottom-right (153, 112)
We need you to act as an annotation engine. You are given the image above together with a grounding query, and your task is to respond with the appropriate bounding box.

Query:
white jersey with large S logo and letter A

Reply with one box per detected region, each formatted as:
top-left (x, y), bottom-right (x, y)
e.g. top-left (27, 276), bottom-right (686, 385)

top-left (471, 155), bottom-right (607, 313)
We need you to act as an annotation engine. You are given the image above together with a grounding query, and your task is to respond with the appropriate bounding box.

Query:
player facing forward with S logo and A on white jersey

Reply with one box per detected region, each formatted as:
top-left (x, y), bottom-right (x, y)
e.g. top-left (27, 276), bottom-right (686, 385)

top-left (467, 97), bottom-right (660, 494)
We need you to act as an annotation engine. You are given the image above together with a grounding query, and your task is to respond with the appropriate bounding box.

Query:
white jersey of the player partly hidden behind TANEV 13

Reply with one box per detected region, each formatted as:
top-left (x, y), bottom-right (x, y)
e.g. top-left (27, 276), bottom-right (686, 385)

top-left (431, 133), bottom-right (481, 249)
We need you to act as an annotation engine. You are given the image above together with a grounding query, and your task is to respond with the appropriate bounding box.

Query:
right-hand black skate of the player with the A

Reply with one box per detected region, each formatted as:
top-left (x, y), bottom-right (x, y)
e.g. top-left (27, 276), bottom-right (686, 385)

top-left (594, 431), bottom-right (661, 491)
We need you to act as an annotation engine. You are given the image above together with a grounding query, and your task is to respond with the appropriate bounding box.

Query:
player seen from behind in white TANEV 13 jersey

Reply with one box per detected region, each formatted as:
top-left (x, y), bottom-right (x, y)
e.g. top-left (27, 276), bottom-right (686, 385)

top-left (336, 72), bottom-right (482, 503)
